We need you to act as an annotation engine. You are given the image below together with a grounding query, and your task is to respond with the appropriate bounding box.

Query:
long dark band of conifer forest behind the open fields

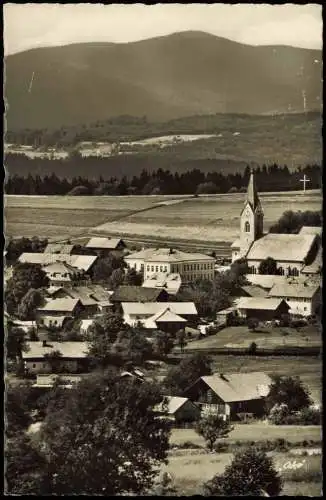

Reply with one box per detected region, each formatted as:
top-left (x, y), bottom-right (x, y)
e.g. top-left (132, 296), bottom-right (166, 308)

top-left (5, 164), bottom-right (322, 196)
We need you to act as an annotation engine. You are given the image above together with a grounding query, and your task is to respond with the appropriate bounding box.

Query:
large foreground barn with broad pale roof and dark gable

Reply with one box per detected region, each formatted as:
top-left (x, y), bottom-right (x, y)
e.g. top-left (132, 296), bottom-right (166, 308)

top-left (184, 372), bottom-right (272, 420)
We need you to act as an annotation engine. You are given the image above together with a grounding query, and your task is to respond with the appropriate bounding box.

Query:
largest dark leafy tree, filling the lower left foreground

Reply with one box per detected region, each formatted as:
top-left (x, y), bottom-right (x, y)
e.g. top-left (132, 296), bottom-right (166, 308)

top-left (42, 370), bottom-right (170, 496)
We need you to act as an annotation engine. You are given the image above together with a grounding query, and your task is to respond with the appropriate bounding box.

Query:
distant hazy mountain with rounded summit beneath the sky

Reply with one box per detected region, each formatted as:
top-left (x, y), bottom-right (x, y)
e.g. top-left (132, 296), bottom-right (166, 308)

top-left (5, 32), bottom-right (322, 129)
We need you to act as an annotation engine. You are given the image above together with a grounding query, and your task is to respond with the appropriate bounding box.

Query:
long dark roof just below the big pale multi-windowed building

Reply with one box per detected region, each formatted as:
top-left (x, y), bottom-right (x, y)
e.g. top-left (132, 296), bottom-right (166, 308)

top-left (111, 285), bottom-right (169, 304)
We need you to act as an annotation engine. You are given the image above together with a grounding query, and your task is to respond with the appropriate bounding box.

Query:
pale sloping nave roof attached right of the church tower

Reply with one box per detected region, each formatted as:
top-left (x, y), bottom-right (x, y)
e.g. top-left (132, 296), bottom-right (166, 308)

top-left (247, 233), bottom-right (315, 263)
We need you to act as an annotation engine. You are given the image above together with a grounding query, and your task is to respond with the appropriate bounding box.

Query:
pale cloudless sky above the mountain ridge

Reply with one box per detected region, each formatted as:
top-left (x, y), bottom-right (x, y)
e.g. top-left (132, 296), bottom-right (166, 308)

top-left (4, 3), bottom-right (322, 55)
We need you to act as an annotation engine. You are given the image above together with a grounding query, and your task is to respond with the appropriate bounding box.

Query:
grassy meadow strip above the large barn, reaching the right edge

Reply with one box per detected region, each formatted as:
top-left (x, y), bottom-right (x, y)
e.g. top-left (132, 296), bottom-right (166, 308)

top-left (185, 325), bottom-right (322, 350)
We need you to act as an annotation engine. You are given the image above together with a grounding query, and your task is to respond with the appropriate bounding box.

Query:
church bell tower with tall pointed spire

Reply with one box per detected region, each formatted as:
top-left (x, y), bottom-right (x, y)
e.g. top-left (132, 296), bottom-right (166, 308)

top-left (240, 170), bottom-right (264, 256)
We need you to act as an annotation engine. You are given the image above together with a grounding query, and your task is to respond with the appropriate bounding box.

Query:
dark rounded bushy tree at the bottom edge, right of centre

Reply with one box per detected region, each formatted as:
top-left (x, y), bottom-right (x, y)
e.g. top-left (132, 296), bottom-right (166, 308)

top-left (204, 447), bottom-right (282, 497)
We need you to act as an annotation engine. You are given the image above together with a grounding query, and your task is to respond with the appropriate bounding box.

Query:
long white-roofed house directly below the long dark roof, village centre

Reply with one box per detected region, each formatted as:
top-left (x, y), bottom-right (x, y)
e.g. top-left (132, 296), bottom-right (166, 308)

top-left (121, 302), bottom-right (198, 326)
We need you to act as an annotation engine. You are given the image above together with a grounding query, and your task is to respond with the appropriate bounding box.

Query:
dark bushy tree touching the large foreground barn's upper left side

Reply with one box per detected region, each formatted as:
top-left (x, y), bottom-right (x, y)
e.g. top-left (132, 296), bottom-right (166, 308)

top-left (163, 353), bottom-right (212, 396)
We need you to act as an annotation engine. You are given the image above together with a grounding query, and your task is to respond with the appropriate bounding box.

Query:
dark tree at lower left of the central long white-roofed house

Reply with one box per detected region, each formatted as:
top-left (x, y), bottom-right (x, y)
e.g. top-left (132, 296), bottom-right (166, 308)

top-left (86, 313), bottom-right (127, 366)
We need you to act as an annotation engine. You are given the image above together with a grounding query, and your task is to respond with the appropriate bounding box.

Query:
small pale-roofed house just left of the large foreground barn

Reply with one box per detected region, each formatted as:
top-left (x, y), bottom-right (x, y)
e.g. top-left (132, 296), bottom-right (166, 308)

top-left (153, 396), bottom-right (200, 424)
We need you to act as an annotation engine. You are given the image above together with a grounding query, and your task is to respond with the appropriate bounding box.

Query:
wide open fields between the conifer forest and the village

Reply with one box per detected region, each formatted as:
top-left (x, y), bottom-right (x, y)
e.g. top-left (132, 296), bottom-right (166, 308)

top-left (5, 190), bottom-right (322, 247)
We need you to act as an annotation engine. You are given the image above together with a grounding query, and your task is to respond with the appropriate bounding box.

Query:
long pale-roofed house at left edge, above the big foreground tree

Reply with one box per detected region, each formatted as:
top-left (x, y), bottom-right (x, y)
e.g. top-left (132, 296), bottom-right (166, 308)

top-left (22, 341), bottom-right (88, 374)
